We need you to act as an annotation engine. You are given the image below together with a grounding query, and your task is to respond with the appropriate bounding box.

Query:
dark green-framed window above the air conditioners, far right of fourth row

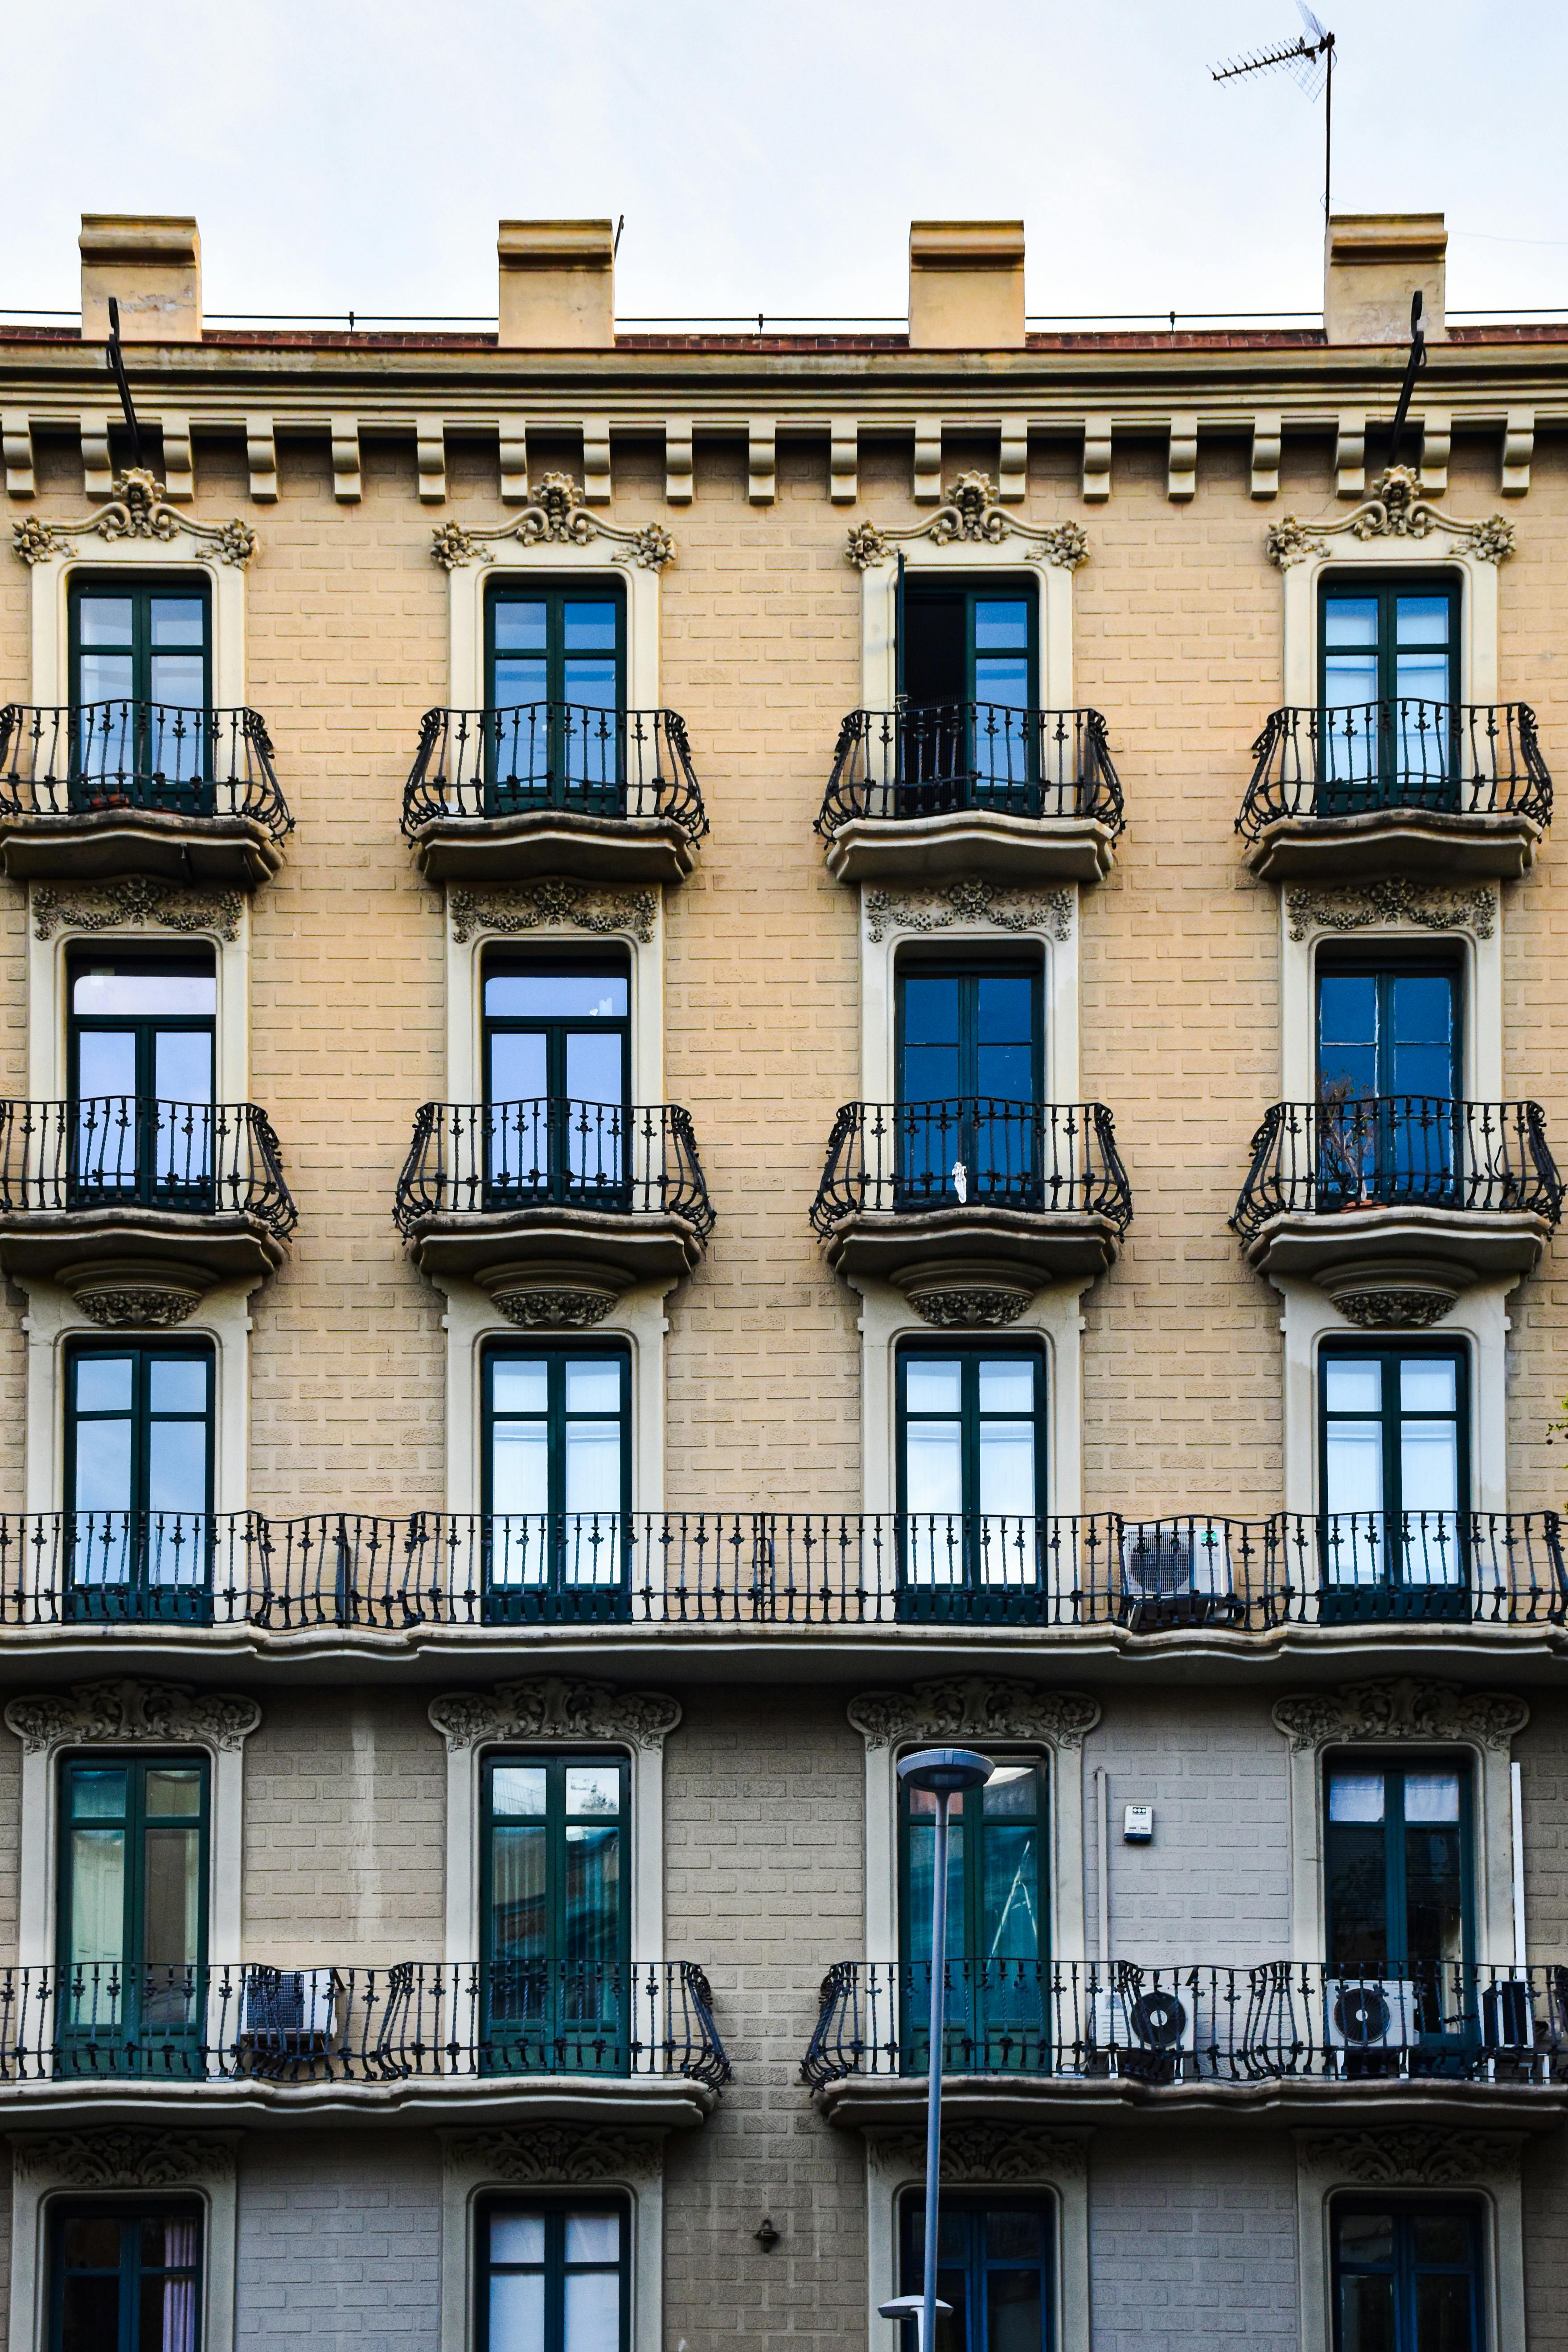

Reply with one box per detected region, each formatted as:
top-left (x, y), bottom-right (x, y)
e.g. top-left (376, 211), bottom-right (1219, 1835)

top-left (1323, 1750), bottom-right (1476, 1975)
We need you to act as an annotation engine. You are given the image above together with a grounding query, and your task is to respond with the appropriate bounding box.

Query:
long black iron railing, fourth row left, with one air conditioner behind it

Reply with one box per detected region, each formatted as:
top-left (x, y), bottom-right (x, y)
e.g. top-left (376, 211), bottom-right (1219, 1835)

top-left (0, 1959), bottom-right (729, 2089)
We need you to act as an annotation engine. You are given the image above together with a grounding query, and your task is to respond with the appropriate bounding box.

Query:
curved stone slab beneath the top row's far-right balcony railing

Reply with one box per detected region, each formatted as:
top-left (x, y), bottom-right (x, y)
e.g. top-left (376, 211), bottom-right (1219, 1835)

top-left (1246, 809), bottom-right (1542, 884)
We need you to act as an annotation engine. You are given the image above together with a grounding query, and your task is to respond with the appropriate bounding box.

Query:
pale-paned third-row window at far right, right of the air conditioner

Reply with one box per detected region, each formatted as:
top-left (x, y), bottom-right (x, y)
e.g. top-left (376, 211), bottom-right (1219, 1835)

top-left (1319, 1343), bottom-right (1469, 1616)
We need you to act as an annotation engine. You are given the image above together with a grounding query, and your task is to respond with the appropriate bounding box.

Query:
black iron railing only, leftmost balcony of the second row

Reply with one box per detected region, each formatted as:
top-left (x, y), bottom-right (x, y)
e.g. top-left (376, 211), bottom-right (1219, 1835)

top-left (0, 1094), bottom-right (299, 1237)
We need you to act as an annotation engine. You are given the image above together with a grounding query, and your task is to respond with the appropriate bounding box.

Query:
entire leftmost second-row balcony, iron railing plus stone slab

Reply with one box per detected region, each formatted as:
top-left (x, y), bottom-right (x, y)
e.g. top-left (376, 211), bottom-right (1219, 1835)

top-left (0, 1094), bottom-right (296, 1296)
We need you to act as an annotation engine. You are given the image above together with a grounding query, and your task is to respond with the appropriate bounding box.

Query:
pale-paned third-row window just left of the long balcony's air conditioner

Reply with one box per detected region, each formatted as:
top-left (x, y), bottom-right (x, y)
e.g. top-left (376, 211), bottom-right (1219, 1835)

top-left (898, 1345), bottom-right (1046, 1616)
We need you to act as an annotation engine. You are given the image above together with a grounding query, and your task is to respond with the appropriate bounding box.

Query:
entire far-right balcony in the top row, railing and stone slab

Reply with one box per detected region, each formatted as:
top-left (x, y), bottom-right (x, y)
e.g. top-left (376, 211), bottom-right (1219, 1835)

top-left (1236, 698), bottom-right (1552, 882)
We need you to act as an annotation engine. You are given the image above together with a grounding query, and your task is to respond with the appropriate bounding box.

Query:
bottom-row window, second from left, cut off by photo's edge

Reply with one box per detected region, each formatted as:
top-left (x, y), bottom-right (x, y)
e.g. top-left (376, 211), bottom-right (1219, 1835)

top-left (477, 2197), bottom-right (632, 2352)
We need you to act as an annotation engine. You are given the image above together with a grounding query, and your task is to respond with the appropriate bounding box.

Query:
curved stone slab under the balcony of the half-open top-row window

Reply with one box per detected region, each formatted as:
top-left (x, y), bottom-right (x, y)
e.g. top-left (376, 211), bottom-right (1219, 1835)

top-left (825, 809), bottom-right (1116, 884)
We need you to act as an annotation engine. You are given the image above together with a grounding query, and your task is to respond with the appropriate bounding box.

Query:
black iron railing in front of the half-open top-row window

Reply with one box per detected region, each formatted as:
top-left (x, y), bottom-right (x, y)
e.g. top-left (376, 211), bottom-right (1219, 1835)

top-left (816, 703), bottom-right (1124, 835)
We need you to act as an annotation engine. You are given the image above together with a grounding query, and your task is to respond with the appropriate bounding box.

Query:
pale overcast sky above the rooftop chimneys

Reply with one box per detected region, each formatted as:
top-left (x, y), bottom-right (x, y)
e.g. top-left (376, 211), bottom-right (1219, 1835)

top-left (0, 0), bottom-right (1568, 317)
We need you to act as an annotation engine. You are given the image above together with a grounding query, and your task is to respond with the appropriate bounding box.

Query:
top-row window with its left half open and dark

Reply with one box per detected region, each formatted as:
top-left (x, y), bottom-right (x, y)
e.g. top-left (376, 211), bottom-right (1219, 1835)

top-left (898, 574), bottom-right (1042, 816)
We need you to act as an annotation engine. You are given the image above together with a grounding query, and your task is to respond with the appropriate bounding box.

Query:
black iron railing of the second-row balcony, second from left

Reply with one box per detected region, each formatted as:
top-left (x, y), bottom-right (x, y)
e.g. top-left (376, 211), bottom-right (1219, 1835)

top-left (393, 1096), bottom-right (714, 1235)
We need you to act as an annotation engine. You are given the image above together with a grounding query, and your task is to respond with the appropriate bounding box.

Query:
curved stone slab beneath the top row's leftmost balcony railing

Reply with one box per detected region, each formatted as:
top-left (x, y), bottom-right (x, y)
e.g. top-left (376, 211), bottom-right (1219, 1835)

top-left (0, 807), bottom-right (282, 889)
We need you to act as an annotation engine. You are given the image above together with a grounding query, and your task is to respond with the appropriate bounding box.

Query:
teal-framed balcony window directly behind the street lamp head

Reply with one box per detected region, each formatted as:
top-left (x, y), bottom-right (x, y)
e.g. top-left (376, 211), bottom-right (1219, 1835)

top-left (898, 1755), bottom-right (1051, 2074)
